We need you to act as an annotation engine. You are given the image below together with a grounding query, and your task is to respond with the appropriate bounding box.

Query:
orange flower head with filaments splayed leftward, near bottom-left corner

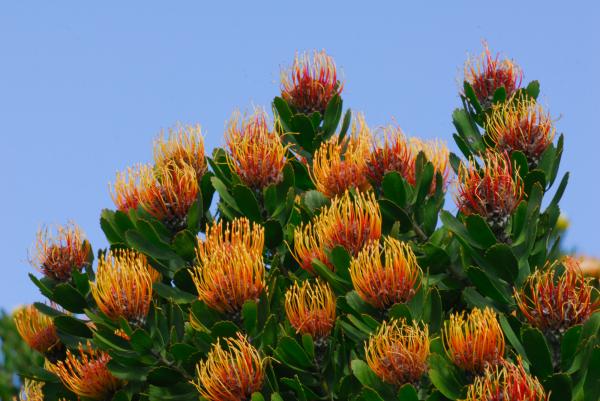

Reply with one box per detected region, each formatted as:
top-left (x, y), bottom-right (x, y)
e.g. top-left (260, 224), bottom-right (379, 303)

top-left (48, 340), bottom-right (123, 400)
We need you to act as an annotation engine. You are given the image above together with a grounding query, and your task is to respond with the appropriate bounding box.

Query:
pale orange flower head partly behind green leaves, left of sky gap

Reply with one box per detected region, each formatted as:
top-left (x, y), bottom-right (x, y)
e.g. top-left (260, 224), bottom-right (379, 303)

top-left (406, 138), bottom-right (450, 195)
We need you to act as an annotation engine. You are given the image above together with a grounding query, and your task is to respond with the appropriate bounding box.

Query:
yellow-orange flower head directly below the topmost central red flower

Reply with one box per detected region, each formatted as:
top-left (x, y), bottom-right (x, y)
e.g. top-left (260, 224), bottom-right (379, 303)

top-left (309, 114), bottom-right (371, 198)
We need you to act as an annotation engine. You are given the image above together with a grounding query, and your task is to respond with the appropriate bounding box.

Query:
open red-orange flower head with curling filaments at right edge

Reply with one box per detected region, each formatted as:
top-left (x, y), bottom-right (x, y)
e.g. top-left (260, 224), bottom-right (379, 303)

top-left (515, 257), bottom-right (600, 334)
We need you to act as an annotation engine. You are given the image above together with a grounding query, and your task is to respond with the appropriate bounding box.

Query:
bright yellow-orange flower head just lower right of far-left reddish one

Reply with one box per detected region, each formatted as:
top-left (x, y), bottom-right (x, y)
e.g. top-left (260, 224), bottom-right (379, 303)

top-left (91, 249), bottom-right (152, 323)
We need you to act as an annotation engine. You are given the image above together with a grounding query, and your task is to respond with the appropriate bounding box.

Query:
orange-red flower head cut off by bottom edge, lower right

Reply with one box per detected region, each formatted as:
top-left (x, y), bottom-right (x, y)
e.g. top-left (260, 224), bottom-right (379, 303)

top-left (465, 358), bottom-right (549, 401)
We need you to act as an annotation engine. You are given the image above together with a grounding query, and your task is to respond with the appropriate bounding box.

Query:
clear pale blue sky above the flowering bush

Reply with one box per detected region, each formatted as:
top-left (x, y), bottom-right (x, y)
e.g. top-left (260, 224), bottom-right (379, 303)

top-left (0, 0), bottom-right (600, 309)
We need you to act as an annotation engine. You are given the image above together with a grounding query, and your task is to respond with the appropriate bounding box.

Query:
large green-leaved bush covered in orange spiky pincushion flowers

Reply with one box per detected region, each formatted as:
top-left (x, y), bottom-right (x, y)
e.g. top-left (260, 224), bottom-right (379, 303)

top-left (14, 48), bottom-right (600, 401)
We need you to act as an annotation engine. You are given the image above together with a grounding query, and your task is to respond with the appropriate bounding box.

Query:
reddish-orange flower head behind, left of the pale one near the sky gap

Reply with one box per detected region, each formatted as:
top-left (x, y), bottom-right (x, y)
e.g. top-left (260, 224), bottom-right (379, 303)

top-left (366, 125), bottom-right (413, 187)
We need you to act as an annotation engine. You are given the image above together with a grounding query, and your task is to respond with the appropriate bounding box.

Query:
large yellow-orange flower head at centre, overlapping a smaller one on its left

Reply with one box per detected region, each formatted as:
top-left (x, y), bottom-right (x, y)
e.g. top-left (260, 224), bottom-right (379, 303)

top-left (315, 192), bottom-right (381, 256)
